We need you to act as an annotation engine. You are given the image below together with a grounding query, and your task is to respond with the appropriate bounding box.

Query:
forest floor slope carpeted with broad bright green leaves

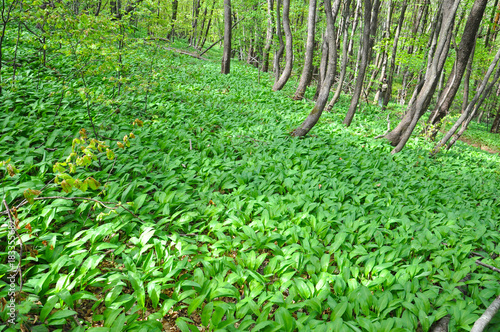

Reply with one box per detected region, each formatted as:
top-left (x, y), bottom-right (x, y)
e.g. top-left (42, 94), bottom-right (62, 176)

top-left (0, 39), bottom-right (500, 332)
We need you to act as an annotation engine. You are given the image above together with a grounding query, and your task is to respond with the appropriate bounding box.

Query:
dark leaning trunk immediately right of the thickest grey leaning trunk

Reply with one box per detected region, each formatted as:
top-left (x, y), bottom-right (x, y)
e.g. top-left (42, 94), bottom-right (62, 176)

top-left (427, 0), bottom-right (488, 137)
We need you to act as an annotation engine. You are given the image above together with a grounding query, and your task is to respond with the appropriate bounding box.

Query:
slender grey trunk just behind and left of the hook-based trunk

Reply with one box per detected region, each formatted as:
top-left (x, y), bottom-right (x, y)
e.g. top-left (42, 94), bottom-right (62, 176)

top-left (293, 0), bottom-right (316, 100)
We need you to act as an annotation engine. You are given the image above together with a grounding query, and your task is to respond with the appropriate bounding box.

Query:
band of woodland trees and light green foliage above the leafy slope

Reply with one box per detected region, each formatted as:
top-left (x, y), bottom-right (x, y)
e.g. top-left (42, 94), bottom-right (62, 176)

top-left (0, 0), bottom-right (500, 152)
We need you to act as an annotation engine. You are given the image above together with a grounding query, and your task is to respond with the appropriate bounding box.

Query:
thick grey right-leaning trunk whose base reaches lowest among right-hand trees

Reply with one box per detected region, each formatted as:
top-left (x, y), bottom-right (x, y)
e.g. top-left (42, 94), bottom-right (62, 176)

top-left (385, 0), bottom-right (460, 154)
